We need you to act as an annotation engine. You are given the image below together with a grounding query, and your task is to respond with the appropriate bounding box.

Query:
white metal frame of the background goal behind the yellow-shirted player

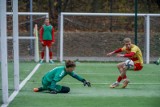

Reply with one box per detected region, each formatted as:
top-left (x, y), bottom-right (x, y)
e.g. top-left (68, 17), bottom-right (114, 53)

top-left (60, 12), bottom-right (160, 64)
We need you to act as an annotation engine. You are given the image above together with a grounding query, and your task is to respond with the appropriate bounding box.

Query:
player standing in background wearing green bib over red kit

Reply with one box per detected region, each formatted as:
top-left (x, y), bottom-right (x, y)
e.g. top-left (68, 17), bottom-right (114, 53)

top-left (39, 18), bottom-right (55, 63)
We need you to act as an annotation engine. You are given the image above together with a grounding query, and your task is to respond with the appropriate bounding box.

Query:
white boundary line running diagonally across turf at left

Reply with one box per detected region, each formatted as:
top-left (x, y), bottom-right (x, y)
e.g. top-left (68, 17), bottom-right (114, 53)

top-left (1, 64), bottom-right (41, 107)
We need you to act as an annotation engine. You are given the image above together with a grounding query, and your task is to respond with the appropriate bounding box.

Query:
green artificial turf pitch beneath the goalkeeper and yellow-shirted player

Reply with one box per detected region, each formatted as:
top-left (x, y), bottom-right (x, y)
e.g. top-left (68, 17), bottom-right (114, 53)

top-left (0, 63), bottom-right (160, 107)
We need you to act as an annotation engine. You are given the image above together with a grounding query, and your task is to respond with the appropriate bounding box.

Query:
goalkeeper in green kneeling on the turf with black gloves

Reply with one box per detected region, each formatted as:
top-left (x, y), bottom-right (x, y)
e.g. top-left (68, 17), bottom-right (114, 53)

top-left (33, 60), bottom-right (91, 94)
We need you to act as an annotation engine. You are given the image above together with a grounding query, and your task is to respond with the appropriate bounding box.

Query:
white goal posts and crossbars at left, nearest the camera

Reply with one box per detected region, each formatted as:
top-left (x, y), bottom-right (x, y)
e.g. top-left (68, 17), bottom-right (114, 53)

top-left (0, 0), bottom-right (49, 106)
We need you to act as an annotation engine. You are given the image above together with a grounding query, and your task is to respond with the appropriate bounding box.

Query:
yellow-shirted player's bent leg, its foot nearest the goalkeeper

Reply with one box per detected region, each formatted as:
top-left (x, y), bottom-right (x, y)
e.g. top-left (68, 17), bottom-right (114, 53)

top-left (110, 62), bottom-right (127, 88)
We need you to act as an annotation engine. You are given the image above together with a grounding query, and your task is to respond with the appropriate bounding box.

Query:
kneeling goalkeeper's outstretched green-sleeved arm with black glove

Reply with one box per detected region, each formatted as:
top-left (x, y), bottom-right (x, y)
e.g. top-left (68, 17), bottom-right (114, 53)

top-left (69, 72), bottom-right (91, 87)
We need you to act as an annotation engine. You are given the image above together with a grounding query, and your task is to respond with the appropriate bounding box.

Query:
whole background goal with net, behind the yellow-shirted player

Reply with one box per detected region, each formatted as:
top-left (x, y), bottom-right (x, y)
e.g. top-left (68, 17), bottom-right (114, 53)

top-left (60, 12), bottom-right (160, 63)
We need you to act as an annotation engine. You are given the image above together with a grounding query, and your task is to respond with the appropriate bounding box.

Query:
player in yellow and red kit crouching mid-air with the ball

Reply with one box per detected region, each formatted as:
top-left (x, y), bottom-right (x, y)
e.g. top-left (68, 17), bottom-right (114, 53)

top-left (107, 38), bottom-right (143, 88)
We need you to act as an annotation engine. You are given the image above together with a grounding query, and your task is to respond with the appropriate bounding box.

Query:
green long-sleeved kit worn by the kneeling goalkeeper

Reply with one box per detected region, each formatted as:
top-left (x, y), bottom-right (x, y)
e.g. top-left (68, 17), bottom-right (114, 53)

top-left (42, 66), bottom-right (85, 92)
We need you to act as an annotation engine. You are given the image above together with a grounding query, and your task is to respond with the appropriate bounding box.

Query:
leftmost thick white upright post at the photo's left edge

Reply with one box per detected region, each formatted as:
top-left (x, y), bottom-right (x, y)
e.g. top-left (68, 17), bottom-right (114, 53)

top-left (0, 0), bottom-right (8, 103)
